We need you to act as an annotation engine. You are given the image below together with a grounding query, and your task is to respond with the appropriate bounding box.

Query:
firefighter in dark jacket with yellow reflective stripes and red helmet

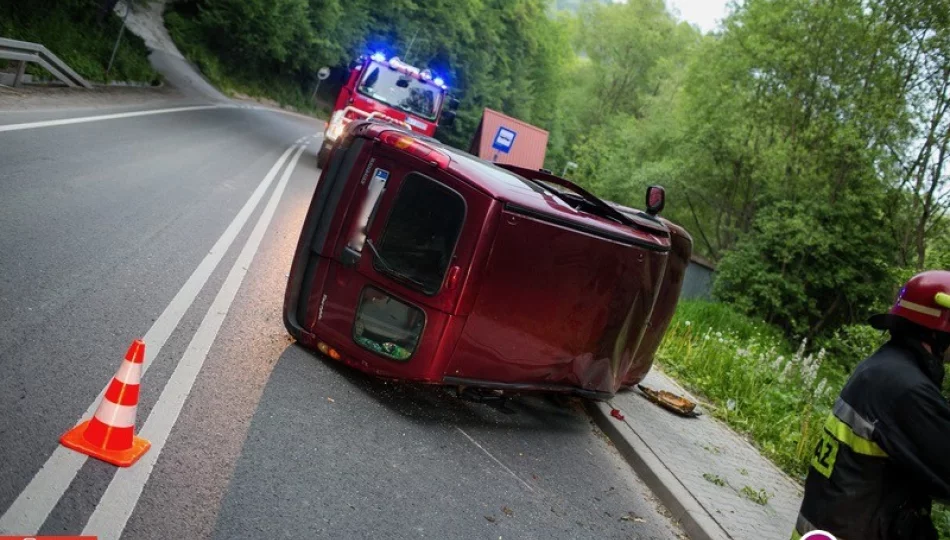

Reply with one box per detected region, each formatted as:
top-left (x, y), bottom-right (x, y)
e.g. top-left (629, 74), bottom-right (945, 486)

top-left (792, 270), bottom-right (950, 540)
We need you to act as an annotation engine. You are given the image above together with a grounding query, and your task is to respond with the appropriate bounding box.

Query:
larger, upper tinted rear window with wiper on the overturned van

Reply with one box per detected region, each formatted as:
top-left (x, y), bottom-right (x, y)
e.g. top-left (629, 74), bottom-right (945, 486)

top-left (373, 173), bottom-right (465, 295)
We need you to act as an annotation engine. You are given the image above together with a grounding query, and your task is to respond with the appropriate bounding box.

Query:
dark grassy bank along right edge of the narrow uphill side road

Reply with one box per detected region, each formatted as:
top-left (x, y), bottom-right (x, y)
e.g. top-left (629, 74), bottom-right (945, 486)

top-left (165, 11), bottom-right (330, 118)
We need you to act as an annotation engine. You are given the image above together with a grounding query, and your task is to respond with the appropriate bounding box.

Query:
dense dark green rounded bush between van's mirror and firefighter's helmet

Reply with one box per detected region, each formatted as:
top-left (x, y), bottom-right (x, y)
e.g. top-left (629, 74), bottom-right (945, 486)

top-left (715, 195), bottom-right (898, 337)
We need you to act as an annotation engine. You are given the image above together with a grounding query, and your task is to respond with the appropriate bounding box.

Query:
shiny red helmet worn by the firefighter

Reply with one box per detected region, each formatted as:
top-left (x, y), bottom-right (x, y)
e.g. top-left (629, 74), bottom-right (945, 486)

top-left (869, 270), bottom-right (950, 333)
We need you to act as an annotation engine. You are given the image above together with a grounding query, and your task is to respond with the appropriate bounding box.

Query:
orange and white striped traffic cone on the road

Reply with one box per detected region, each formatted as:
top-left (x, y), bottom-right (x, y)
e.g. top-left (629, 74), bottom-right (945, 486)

top-left (59, 339), bottom-right (152, 467)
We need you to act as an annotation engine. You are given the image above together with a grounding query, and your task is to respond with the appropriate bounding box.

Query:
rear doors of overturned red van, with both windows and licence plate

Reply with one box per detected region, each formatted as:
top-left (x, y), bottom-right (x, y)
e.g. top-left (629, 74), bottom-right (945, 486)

top-left (308, 146), bottom-right (489, 379)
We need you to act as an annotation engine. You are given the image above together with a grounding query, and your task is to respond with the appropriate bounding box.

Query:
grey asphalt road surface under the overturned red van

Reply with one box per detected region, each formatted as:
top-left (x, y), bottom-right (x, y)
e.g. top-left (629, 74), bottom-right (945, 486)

top-left (0, 103), bottom-right (682, 539)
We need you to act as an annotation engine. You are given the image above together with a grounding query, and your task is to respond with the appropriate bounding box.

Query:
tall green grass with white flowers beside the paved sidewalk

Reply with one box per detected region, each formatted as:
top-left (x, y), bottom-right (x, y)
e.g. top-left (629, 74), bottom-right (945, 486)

top-left (657, 301), bottom-right (950, 540)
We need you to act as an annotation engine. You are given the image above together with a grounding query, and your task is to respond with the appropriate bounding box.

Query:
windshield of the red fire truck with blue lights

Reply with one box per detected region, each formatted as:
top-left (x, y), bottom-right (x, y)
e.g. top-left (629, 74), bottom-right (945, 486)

top-left (358, 61), bottom-right (442, 120)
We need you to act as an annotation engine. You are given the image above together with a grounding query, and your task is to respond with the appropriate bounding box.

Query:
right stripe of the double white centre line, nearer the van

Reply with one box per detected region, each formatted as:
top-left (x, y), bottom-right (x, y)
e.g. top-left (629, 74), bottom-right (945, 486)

top-left (82, 146), bottom-right (304, 540)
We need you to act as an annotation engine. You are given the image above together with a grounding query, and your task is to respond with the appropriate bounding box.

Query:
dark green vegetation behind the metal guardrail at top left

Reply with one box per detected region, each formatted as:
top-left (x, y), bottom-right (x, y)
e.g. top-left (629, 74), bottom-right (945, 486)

top-left (0, 0), bottom-right (161, 84)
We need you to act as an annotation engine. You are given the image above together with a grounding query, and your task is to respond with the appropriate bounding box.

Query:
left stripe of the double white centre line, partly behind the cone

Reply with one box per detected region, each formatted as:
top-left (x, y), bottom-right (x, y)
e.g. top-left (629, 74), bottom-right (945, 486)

top-left (0, 141), bottom-right (294, 534)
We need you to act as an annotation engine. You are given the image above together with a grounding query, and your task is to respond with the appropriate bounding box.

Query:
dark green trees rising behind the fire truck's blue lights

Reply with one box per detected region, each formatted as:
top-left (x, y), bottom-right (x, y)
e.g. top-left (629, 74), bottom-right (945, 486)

top-left (168, 0), bottom-right (573, 147)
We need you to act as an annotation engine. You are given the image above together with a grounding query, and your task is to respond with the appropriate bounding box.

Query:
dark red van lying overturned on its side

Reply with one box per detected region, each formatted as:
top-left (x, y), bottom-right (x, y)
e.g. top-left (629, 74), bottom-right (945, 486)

top-left (284, 122), bottom-right (692, 399)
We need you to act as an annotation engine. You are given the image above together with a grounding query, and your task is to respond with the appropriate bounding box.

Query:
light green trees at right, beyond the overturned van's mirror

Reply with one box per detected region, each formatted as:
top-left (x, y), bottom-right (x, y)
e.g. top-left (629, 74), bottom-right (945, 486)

top-left (562, 0), bottom-right (950, 337)
